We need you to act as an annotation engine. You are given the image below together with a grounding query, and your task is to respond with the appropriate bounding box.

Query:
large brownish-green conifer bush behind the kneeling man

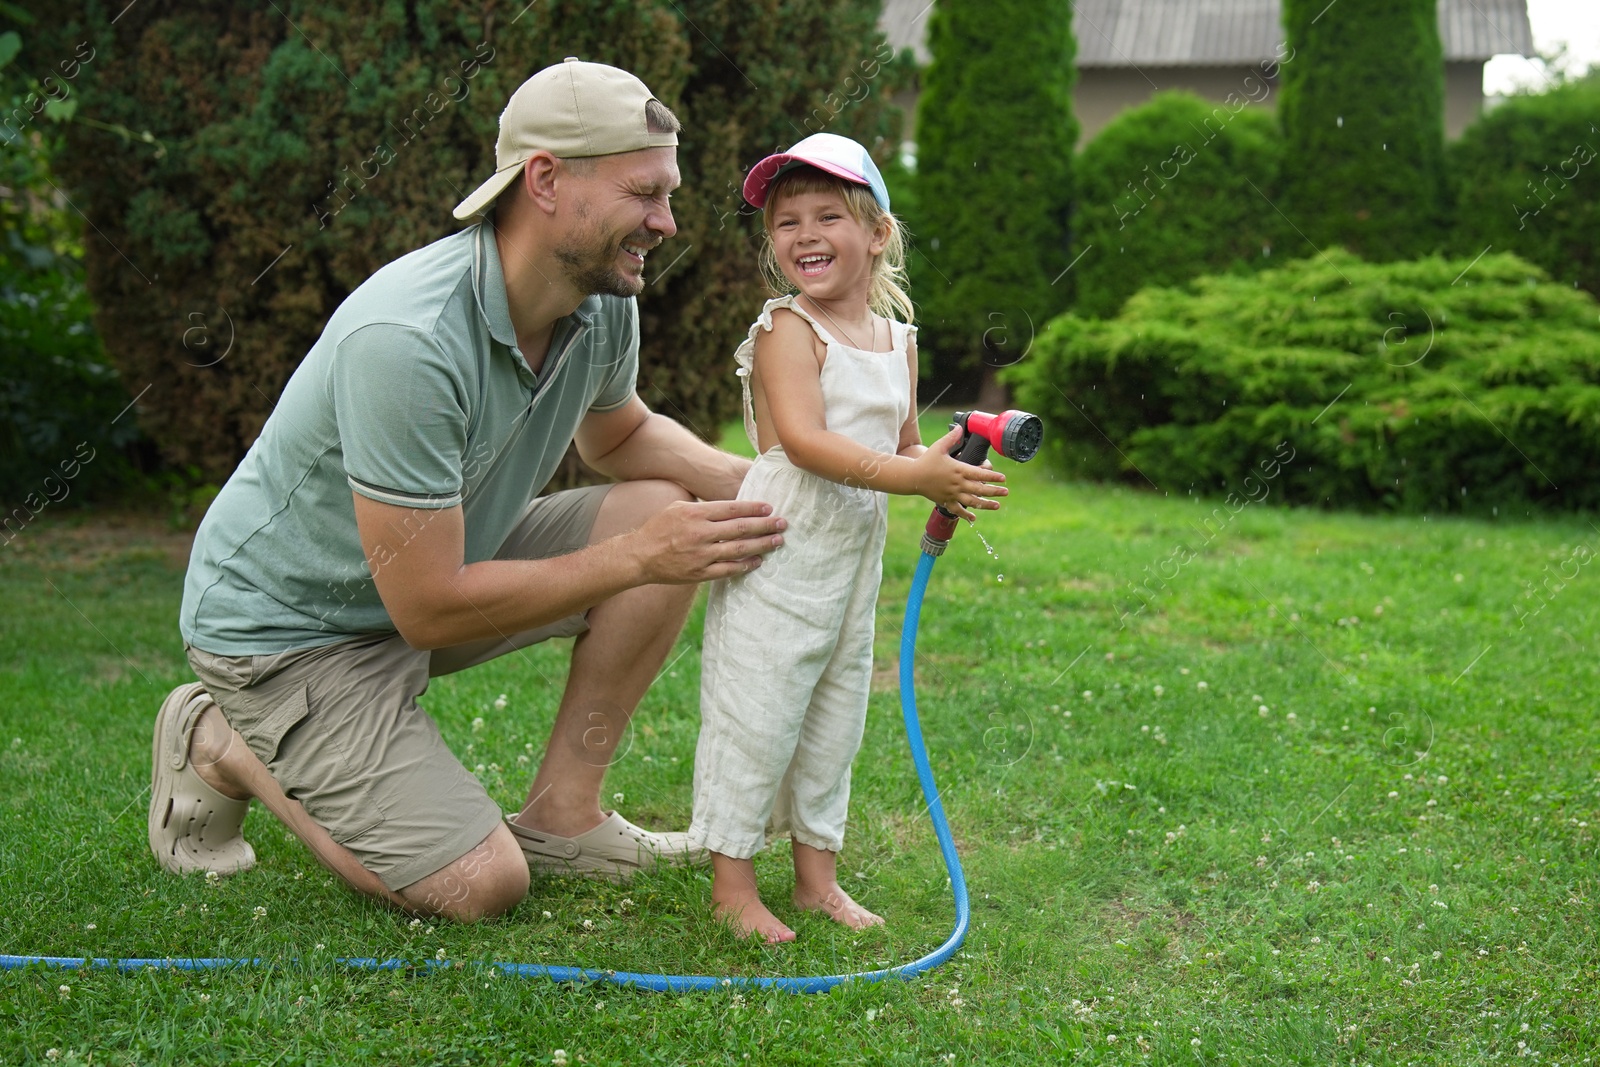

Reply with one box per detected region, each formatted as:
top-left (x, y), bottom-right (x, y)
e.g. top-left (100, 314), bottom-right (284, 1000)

top-left (25, 0), bottom-right (896, 478)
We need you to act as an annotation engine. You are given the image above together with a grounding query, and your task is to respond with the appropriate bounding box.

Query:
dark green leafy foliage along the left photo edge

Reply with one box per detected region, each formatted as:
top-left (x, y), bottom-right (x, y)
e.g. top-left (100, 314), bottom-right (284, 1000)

top-left (0, 13), bottom-right (139, 511)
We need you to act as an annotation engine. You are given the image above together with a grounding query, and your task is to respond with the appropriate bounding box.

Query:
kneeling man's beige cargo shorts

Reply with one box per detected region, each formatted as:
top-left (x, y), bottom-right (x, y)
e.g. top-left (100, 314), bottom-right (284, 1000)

top-left (187, 486), bottom-right (610, 889)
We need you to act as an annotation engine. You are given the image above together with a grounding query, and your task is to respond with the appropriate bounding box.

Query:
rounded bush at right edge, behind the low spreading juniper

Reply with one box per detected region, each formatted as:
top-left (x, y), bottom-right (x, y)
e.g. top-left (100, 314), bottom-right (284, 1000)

top-left (1448, 74), bottom-right (1600, 294)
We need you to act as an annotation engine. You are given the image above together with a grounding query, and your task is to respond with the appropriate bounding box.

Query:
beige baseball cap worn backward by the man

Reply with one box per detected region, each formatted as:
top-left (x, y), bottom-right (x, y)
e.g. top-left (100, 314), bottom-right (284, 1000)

top-left (454, 56), bottom-right (678, 219)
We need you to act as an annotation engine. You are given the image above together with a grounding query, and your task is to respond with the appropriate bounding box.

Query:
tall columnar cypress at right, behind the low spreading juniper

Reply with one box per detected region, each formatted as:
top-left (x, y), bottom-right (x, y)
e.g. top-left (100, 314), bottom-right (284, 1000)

top-left (1278, 0), bottom-right (1446, 259)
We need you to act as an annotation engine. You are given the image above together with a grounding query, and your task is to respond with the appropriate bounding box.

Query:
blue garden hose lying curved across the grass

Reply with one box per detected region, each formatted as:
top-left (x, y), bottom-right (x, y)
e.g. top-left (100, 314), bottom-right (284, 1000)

top-left (0, 545), bottom-right (971, 993)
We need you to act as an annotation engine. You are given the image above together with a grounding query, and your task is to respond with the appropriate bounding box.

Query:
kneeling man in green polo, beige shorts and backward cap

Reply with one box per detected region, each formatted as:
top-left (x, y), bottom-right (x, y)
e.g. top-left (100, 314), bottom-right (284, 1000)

top-left (149, 59), bottom-right (784, 920)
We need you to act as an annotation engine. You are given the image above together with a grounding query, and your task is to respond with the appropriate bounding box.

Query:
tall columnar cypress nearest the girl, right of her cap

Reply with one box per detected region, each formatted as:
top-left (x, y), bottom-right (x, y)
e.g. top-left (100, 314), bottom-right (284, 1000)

top-left (912, 0), bottom-right (1078, 396)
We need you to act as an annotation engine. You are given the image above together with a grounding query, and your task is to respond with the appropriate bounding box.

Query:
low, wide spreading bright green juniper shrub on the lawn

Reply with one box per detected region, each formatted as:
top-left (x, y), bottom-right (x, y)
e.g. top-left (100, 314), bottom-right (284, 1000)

top-left (1008, 250), bottom-right (1600, 512)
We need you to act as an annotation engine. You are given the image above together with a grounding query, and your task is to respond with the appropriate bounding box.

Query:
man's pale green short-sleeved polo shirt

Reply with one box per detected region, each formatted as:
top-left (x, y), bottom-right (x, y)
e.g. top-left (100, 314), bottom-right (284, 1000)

top-left (179, 224), bottom-right (638, 656)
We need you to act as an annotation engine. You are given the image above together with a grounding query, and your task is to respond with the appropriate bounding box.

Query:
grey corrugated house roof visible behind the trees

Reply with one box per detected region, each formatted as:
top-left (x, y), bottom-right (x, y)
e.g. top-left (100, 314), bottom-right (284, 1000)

top-left (878, 0), bottom-right (1533, 67)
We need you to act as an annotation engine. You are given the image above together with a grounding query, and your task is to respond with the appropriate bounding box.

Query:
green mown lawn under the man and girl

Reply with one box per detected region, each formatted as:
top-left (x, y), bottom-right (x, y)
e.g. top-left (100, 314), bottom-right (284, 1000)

top-left (0, 419), bottom-right (1600, 1065)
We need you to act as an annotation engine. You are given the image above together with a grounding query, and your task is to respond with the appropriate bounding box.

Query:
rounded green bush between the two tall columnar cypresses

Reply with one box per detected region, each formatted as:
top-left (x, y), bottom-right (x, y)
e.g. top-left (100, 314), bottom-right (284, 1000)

top-left (1072, 92), bottom-right (1282, 315)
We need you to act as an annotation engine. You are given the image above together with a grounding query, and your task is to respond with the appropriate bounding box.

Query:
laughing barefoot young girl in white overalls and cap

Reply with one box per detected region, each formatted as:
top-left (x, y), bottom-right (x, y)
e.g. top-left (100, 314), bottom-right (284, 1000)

top-left (690, 133), bottom-right (1006, 944)
